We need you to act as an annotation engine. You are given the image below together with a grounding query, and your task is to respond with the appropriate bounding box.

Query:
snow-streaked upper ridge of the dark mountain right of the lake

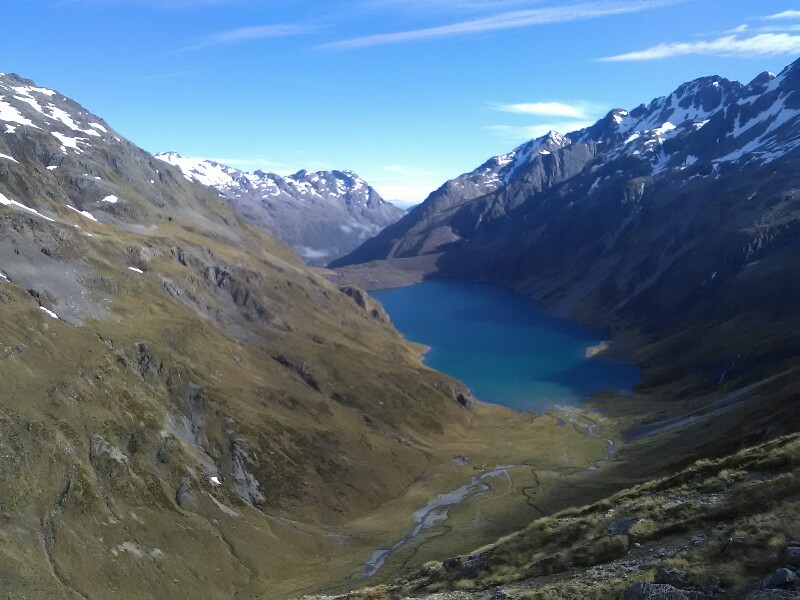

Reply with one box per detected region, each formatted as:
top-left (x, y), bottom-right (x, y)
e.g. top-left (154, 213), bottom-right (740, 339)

top-left (332, 61), bottom-right (800, 266)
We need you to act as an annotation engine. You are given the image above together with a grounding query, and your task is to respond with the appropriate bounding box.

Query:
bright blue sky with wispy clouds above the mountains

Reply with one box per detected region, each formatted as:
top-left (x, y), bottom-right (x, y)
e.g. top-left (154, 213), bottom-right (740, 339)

top-left (0, 0), bottom-right (800, 203)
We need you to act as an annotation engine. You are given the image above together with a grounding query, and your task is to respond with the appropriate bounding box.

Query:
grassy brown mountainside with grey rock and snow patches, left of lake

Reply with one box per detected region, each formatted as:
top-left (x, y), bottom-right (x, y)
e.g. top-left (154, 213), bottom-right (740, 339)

top-left (0, 74), bottom-right (470, 599)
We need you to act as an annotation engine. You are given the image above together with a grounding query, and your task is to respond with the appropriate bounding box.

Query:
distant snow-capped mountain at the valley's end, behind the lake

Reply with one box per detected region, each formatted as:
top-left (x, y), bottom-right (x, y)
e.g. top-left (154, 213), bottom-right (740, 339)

top-left (156, 152), bottom-right (403, 264)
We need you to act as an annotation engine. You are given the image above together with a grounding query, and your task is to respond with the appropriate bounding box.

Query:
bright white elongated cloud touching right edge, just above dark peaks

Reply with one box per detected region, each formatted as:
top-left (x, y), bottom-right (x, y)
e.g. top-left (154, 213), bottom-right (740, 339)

top-left (598, 32), bottom-right (800, 62)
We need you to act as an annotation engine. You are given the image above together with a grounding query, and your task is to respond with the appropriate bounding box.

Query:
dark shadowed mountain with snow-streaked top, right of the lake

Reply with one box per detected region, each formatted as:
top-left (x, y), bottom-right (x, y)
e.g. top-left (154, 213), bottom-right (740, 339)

top-left (330, 61), bottom-right (800, 412)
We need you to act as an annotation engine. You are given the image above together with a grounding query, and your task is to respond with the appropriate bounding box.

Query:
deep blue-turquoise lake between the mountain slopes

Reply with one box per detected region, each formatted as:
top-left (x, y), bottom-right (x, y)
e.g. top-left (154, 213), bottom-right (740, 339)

top-left (372, 280), bottom-right (639, 412)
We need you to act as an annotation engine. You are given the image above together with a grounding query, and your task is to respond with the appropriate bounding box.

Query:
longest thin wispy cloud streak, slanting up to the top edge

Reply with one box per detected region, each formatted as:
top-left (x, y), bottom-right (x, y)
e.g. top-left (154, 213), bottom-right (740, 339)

top-left (320, 0), bottom-right (685, 50)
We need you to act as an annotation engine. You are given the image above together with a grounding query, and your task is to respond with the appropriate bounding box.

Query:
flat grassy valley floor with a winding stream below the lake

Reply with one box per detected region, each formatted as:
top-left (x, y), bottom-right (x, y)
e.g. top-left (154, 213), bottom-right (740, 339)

top-left (294, 404), bottom-right (614, 597)
